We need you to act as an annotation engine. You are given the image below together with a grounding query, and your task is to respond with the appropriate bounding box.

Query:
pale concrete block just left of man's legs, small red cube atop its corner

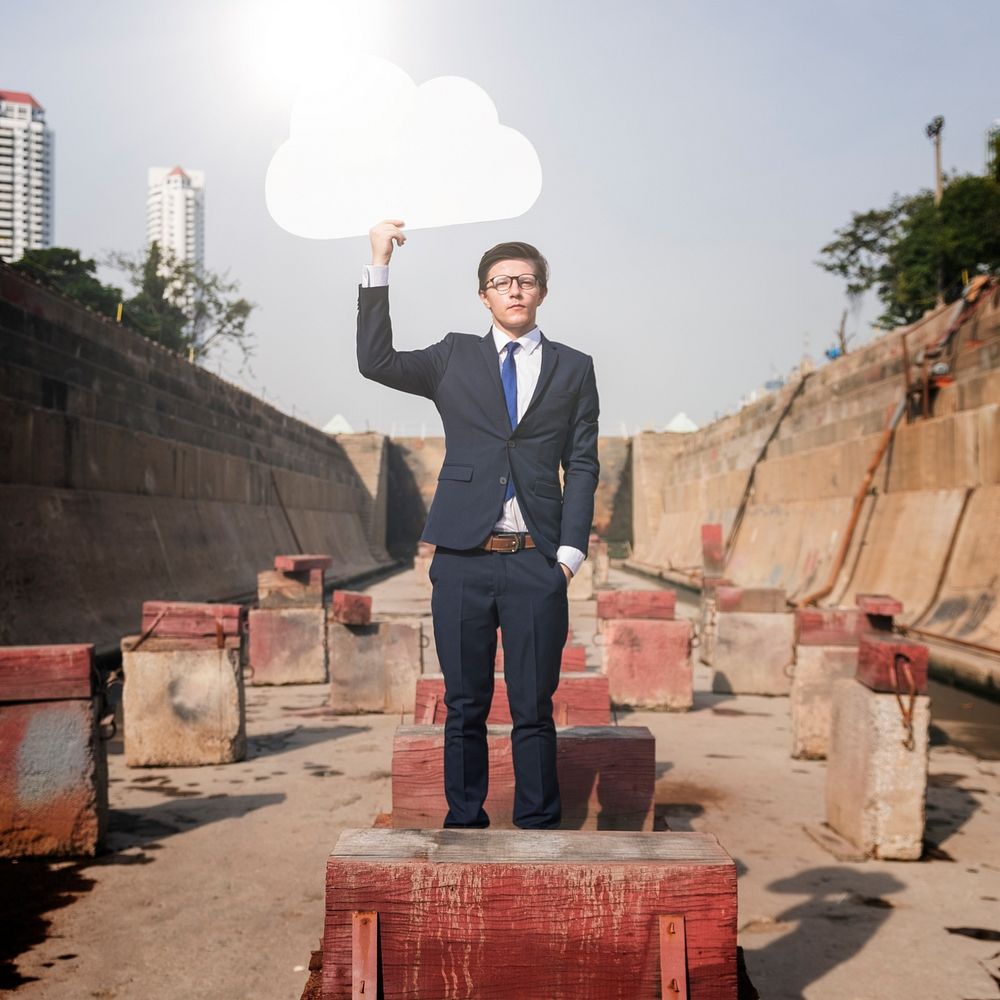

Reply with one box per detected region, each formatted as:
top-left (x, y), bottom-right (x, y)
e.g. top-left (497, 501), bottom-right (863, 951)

top-left (326, 618), bottom-right (423, 715)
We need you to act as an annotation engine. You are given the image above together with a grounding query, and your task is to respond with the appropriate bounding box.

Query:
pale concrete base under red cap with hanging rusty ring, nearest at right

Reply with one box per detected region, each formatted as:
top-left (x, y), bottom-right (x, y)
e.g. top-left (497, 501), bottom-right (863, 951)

top-left (826, 680), bottom-right (931, 861)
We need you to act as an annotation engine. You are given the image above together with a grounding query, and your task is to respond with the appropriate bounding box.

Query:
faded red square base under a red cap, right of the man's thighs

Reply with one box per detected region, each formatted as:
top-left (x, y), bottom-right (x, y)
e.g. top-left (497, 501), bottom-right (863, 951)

top-left (604, 619), bottom-right (694, 711)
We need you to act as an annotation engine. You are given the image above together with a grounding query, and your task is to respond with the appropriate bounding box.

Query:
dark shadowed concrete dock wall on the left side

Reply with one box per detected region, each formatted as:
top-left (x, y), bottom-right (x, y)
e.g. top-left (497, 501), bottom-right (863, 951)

top-left (0, 267), bottom-right (388, 648)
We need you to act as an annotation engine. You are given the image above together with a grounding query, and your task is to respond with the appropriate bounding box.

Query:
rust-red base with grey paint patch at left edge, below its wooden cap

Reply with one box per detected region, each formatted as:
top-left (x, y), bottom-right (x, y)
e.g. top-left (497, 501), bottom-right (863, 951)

top-left (0, 698), bottom-right (108, 857)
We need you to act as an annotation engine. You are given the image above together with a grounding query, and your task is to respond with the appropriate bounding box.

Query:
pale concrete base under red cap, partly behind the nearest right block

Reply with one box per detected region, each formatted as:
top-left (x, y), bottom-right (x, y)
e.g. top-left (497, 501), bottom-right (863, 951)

top-left (790, 646), bottom-right (858, 760)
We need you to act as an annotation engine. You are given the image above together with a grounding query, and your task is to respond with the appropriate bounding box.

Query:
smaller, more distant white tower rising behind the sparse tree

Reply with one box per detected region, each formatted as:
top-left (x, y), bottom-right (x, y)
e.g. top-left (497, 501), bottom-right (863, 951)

top-left (146, 167), bottom-right (205, 267)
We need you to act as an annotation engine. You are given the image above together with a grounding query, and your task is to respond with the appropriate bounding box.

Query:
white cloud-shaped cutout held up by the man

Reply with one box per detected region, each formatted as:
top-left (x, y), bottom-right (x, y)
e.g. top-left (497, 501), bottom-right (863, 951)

top-left (264, 56), bottom-right (542, 239)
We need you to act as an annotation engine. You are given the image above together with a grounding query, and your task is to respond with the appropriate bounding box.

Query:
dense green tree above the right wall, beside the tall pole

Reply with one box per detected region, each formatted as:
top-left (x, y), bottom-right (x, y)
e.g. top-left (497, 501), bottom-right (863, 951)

top-left (817, 176), bottom-right (1000, 327)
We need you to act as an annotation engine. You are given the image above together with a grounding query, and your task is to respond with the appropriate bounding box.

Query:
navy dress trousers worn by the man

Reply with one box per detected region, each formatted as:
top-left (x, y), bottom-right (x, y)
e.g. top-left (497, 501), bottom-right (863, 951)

top-left (430, 548), bottom-right (569, 829)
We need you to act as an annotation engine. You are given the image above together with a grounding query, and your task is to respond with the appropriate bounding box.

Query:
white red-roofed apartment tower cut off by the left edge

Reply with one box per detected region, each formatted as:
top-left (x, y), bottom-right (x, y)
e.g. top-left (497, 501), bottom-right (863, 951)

top-left (0, 90), bottom-right (53, 263)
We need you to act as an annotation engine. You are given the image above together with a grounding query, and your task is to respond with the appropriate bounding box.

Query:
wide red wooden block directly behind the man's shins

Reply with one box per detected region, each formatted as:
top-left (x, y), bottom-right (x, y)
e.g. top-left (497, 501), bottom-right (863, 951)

top-left (391, 726), bottom-right (656, 830)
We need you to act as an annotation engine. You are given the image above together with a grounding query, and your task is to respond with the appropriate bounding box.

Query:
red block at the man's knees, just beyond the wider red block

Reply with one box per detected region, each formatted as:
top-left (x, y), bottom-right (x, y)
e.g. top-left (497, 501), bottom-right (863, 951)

top-left (413, 672), bottom-right (611, 726)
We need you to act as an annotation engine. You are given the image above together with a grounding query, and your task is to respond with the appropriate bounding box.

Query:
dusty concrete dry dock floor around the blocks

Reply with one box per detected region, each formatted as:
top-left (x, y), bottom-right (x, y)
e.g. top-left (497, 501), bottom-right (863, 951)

top-left (0, 573), bottom-right (1000, 1000)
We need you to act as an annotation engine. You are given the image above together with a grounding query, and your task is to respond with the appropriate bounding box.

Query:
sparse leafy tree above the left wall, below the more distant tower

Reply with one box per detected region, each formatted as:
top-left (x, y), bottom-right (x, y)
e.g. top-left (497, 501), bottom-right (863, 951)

top-left (108, 242), bottom-right (256, 361)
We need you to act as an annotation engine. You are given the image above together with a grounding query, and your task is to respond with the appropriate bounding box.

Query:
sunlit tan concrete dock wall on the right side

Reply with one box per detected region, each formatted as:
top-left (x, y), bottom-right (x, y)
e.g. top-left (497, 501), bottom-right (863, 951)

top-left (632, 286), bottom-right (1000, 686)
